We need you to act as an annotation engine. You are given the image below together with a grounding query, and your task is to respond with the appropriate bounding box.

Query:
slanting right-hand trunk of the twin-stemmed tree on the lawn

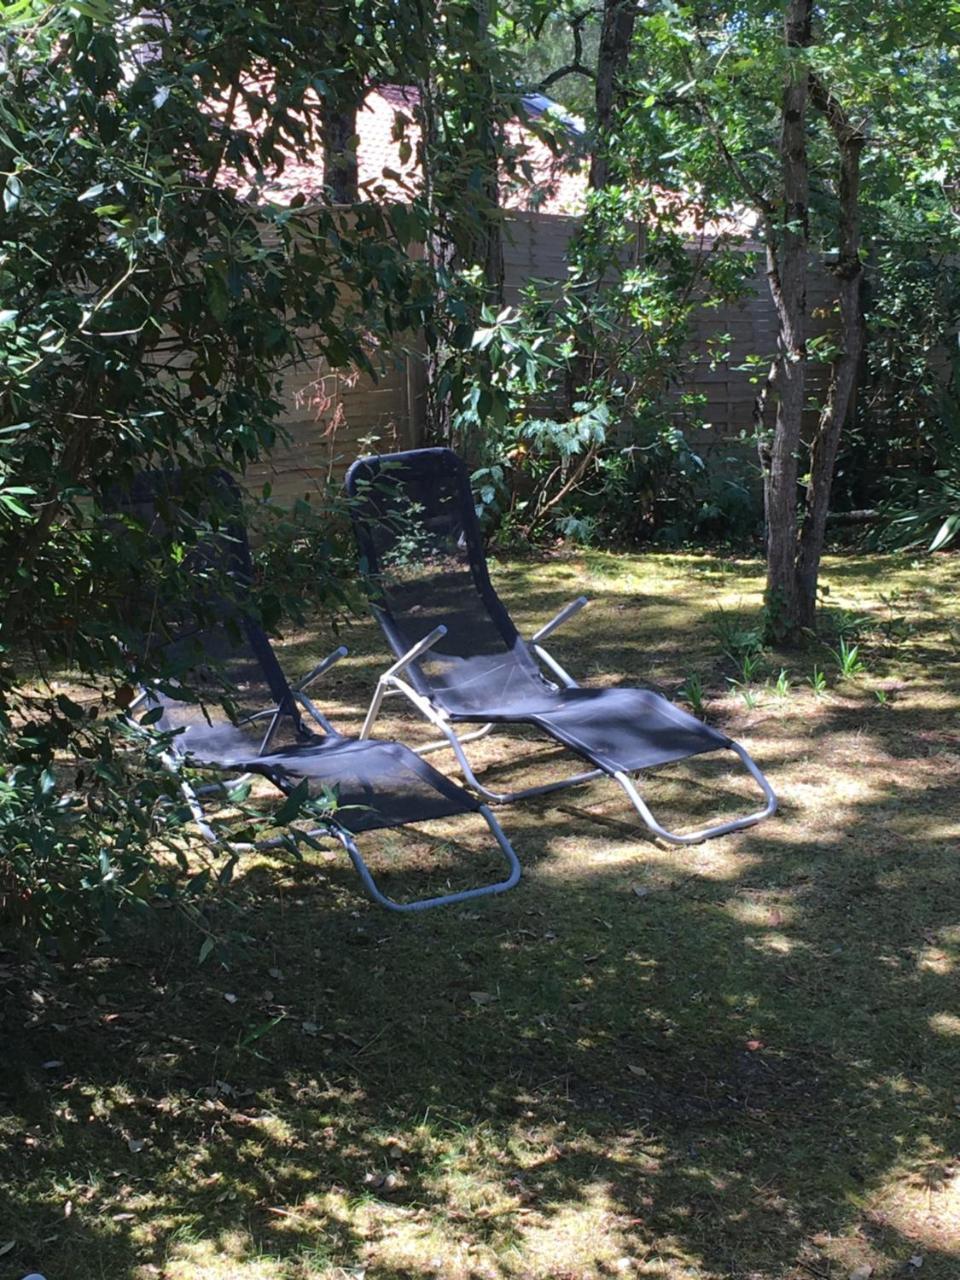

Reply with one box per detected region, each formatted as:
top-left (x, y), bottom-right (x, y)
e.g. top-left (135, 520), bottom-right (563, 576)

top-left (796, 77), bottom-right (865, 627)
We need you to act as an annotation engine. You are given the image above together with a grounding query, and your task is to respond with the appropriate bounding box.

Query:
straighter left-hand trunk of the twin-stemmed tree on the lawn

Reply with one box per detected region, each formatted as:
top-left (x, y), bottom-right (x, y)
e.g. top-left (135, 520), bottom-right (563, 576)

top-left (764, 0), bottom-right (813, 639)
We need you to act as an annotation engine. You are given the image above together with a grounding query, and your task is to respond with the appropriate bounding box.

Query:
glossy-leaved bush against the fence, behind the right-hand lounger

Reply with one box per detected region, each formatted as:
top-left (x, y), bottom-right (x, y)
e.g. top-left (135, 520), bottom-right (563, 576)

top-left (447, 187), bottom-right (748, 543)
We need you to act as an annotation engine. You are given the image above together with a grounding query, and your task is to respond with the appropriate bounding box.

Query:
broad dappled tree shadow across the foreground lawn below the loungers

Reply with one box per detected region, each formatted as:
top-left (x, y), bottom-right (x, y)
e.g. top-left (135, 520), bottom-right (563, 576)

top-left (0, 747), bottom-right (960, 1277)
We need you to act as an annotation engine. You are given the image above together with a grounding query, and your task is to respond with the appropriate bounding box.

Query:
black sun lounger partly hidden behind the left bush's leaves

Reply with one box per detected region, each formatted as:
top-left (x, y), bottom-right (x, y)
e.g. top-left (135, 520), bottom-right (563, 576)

top-left (114, 472), bottom-right (520, 911)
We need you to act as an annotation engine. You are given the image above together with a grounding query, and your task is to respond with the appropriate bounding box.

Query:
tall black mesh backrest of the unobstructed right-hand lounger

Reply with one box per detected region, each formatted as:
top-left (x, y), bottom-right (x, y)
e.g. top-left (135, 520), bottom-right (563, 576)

top-left (346, 449), bottom-right (545, 713)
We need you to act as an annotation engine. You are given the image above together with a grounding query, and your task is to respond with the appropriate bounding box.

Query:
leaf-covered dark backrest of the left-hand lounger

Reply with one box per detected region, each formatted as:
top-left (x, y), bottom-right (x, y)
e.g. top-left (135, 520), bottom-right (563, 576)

top-left (111, 468), bottom-right (316, 748)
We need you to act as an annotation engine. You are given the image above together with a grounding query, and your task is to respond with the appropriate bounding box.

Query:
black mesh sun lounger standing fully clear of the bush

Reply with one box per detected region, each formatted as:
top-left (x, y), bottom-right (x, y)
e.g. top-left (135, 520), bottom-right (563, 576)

top-left (346, 449), bottom-right (777, 845)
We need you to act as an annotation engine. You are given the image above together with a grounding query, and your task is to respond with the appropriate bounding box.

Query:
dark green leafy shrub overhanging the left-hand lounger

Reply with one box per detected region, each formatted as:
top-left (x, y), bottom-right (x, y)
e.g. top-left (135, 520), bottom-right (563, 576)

top-left (0, 0), bottom-right (440, 954)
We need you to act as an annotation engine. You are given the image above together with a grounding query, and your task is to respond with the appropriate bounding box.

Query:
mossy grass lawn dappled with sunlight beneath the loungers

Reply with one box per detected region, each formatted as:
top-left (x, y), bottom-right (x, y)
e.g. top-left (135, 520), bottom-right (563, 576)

top-left (0, 553), bottom-right (960, 1280)
